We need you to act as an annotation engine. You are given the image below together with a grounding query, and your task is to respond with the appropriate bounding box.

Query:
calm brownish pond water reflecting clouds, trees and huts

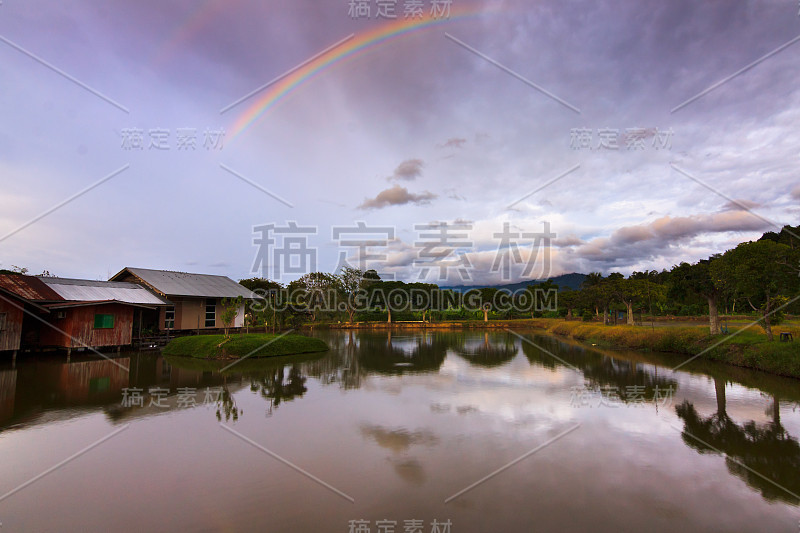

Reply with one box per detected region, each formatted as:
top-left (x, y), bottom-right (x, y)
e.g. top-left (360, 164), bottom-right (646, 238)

top-left (0, 331), bottom-right (800, 533)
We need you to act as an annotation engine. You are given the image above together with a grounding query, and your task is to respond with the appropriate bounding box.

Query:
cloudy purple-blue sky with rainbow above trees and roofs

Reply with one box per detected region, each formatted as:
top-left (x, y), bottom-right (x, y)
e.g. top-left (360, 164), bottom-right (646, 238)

top-left (0, 0), bottom-right (800, 283)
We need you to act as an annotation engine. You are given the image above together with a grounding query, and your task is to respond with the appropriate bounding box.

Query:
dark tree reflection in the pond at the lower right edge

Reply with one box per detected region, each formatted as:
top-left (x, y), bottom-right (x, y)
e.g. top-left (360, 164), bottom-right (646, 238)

top-left (675, 378), bottom-right (800, 505)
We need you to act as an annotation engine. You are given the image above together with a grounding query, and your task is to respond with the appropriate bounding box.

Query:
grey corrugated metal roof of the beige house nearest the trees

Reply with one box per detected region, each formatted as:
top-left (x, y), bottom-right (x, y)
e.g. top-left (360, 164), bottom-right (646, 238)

top-left (111, 267), bottom-right (258, 299)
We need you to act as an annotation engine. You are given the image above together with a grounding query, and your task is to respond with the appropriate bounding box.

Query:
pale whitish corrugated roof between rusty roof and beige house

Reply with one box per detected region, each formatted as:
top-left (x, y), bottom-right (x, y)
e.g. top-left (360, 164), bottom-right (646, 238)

top-left (39, 277), bottom-right (172, 305)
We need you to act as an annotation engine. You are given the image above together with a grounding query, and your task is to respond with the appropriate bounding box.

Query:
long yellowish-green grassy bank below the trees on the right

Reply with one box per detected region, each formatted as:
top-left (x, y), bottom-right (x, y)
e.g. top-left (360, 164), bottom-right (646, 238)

top-left (530, 319), bottom-right (800, 378)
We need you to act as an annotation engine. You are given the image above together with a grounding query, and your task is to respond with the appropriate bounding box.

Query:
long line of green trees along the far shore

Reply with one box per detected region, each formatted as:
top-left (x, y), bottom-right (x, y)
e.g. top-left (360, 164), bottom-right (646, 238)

top-left (240, 226), bottom-right (800, 339)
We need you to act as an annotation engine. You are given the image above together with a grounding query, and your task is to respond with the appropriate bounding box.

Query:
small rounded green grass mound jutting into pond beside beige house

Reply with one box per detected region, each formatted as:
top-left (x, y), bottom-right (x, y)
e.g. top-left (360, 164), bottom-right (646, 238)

top-left (162, 333), bottom-right (328, 359)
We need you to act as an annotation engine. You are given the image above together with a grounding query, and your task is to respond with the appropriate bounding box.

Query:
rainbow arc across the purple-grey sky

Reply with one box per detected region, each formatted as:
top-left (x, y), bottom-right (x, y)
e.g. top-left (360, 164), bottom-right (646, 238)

top-left (225, 2), bottom-right (485, 140)
